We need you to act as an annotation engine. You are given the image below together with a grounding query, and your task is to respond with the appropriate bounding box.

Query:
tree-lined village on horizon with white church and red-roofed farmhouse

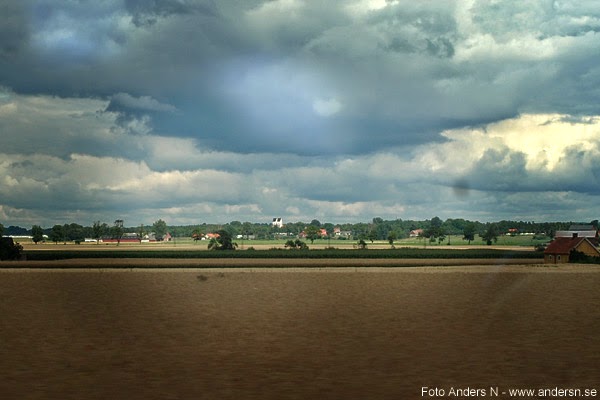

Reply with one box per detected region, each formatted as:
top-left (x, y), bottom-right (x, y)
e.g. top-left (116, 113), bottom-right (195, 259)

top-left (0, 217), bottom-right (600, 264)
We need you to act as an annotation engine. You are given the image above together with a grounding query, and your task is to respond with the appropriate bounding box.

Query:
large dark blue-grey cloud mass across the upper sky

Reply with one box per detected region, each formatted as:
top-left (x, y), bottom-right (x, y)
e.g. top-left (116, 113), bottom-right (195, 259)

top-left (2, 0), bottom-right (600, 154)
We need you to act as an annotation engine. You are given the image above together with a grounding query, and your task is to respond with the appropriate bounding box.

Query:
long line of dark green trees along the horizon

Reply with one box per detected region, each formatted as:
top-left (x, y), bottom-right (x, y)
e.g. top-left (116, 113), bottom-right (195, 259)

top-left (3, 216), bottom-right (584, 245)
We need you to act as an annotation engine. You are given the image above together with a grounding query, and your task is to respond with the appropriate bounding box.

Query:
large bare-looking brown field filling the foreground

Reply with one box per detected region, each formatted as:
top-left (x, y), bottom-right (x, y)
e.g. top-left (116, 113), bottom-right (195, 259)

top-left (0, 260), bottom-right (600, 399)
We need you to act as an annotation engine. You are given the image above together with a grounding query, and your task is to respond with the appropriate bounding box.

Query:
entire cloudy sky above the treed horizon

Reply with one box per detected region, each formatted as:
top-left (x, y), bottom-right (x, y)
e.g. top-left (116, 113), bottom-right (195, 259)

top-left (0, 0), bottom-right (600, 227)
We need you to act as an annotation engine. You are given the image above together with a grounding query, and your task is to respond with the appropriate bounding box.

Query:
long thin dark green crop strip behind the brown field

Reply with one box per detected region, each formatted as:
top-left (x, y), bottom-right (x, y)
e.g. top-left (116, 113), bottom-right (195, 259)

top-left (26, 248), bottom-right (542, 261)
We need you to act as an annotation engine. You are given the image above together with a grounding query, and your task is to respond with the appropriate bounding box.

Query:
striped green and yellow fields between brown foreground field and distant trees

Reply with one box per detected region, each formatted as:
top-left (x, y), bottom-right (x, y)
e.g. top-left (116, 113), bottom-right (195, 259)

top-left (11, 231), bottom-right (547, 261)
